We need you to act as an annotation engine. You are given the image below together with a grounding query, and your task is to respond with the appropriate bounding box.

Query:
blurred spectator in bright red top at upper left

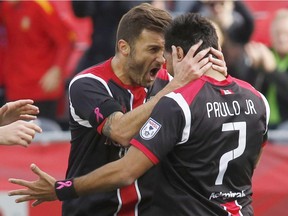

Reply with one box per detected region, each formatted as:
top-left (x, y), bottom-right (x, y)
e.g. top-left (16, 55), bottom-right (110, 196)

top-left (0, 0), bottom-right (74, 125)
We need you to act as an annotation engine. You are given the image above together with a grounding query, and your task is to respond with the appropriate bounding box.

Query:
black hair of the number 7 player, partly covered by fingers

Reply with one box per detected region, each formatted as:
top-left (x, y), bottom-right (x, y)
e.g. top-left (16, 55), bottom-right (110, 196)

top-left (165, 13), bottom-right (218, 55)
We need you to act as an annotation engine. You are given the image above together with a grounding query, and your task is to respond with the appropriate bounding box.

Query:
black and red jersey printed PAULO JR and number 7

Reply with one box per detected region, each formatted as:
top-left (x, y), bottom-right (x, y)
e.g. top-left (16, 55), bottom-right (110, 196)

top-left (131, 76), bottom-right (269, 216)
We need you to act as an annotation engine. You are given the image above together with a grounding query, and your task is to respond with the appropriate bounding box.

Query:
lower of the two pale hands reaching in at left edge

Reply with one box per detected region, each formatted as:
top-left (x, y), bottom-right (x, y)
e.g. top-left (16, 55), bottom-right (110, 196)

top-left (0, 120), bottom-right (42, 147)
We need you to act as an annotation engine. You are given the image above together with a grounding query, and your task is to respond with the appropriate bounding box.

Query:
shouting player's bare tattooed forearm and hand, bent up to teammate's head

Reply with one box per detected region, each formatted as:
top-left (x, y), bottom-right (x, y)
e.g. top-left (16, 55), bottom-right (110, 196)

top-left (102, 42), bottom-right (214, 146)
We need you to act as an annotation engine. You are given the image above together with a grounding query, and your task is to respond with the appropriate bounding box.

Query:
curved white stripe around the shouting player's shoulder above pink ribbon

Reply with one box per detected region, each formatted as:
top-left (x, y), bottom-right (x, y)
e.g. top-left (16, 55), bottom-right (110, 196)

top-left (69, 74), bottom-right (113, 128)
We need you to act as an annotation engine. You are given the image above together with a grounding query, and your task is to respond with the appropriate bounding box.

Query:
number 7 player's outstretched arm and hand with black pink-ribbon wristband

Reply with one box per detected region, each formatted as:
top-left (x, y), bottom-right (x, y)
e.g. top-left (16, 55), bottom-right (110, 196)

top-left (8, 146), bottom-right (153, 206)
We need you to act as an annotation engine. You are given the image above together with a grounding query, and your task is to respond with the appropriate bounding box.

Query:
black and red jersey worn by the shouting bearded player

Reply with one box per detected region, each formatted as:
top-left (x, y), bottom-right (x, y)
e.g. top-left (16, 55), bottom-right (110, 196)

top-left (63, 59), bottom-right (169, 216)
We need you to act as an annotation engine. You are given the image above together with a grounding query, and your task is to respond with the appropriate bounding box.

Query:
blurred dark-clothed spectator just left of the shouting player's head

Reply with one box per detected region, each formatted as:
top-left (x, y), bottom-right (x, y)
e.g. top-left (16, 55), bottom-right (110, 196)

top-left (71, 1), bottom-right (132, 73)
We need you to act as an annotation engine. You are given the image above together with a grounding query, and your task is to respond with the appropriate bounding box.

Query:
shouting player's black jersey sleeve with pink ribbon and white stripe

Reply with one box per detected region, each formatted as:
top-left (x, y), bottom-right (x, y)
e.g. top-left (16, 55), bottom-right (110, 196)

top-left (69, 75), bottom-right (122, 128)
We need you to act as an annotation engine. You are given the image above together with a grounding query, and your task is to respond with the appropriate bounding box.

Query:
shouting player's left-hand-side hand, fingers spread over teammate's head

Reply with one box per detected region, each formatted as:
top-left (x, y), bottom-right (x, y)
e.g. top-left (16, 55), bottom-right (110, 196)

top-left (172, 41), bottom-right (212, 86)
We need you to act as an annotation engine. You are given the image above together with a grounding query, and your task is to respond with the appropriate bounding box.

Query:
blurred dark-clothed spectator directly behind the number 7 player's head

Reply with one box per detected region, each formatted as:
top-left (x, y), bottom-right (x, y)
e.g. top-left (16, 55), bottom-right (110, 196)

top-left (189, 0), bottom-right (255, 84)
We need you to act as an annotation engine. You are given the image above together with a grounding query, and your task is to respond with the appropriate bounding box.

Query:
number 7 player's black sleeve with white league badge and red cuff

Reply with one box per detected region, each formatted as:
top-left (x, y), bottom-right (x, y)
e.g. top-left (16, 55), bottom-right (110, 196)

top-left (131, 94), bottom-right (185, 164)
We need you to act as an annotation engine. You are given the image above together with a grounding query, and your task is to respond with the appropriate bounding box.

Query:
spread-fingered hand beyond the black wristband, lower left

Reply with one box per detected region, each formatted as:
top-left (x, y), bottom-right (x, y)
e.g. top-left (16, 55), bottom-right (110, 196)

top-left (8, 164), bottom-right (57, 206)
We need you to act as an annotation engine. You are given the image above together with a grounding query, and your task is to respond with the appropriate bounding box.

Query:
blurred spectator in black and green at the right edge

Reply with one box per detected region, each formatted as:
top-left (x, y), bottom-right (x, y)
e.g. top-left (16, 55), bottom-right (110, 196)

top-left (246, 9), bottom-right (288, 129)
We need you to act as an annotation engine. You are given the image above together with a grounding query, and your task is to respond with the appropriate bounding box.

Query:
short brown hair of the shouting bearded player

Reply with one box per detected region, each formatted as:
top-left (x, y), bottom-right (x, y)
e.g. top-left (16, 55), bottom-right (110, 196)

top-left (116, 3), bottom-right (172, 52)
